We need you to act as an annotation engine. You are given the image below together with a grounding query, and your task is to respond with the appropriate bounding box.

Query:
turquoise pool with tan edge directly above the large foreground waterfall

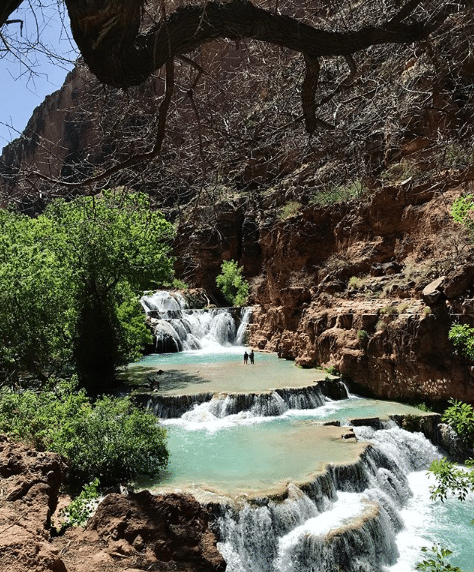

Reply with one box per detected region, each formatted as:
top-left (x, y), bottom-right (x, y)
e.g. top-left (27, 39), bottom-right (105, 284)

top-left (155, 416), bottom-right (360, 495)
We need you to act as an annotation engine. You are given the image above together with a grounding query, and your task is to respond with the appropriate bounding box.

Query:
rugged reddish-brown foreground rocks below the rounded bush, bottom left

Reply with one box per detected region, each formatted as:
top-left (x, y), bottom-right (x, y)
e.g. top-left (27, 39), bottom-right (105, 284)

top-left (0, 436), bottom-right (225, 572)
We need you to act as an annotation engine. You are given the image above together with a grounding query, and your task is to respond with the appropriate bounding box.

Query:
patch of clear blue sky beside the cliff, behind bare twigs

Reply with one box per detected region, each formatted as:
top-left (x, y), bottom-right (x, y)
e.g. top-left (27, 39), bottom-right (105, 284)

top-left (0, 0), bottom-right (77, 149)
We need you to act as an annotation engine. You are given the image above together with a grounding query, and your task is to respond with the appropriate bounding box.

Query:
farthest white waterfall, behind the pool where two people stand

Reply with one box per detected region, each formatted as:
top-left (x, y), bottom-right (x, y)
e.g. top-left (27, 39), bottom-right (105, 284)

top-left (141, 291), bottom-right (252, 353)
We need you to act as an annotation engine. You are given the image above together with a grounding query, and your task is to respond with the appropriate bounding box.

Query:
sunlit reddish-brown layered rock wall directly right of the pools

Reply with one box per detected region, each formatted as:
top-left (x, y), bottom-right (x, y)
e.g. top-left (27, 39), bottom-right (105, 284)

top-left (250, 181), bottom-right (474, 401)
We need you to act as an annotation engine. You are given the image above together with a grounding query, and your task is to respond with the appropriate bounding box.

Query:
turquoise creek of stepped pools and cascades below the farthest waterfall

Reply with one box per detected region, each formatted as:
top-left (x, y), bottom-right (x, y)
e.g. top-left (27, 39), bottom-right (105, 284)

top-left (129, 294), bottom-right (474, 572)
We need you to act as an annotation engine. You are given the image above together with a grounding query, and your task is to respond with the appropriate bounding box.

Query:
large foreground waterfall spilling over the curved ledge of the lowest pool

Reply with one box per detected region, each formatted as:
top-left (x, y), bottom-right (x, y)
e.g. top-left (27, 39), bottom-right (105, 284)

top-left (217, 427), bottom-right (439, 572)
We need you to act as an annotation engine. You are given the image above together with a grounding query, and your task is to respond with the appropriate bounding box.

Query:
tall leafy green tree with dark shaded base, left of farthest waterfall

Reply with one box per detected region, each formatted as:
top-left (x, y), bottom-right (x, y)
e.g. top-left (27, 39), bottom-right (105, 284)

top-left (0, 191), bottom-right (173, 392)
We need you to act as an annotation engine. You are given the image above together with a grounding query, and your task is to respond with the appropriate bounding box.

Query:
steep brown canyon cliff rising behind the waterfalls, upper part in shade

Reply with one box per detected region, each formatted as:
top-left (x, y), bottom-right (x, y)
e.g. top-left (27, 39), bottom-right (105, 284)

top-left (0, 8), bottom-right (474, 400)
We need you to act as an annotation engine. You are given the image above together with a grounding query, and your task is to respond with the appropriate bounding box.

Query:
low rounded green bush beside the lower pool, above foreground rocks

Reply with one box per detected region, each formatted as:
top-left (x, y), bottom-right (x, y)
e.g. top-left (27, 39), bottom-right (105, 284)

top-left (0, 382), bottom-right (168, 484)
